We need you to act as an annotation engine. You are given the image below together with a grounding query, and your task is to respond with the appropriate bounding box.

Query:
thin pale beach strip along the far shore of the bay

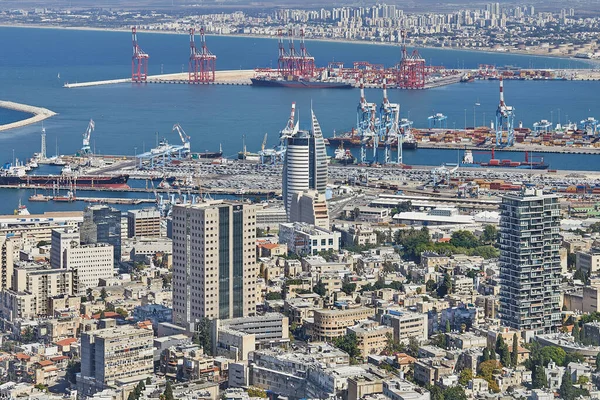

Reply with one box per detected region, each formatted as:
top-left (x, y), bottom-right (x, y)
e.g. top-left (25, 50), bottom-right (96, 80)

top-left (0, 24), bottom-right (600, 69)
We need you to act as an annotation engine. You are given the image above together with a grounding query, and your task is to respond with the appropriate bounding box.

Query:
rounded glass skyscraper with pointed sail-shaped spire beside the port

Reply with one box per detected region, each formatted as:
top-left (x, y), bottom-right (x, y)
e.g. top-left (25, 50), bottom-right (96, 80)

top-left (283, 110), bottom-right (327, 218)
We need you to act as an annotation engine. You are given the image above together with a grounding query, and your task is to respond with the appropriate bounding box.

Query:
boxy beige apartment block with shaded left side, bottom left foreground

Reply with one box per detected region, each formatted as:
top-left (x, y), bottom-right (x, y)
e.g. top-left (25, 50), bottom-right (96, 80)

top-left (77, 325), bottom-right (154, 396)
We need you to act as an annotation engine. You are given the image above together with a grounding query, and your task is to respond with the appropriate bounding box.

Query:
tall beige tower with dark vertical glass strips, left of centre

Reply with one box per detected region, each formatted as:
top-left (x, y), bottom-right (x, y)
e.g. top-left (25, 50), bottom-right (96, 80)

top-left (172, 201), bottom-right (257, 329)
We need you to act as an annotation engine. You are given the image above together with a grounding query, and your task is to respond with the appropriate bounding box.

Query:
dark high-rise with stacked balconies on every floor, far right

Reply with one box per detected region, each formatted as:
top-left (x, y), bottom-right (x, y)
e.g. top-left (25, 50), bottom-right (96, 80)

top-left (500, 189), bottom-right (561, 332)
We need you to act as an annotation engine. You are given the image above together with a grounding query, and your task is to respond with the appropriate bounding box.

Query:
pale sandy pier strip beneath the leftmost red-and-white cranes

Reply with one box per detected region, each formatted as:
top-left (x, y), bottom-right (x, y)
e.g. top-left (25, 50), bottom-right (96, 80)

top-left (64, 69), bottom-right (254, 89)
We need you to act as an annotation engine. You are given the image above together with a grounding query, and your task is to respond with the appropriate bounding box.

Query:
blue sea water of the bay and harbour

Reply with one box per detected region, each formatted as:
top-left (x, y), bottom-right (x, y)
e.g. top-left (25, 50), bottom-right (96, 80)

top-left (0, 28), bottom-right (600, 212)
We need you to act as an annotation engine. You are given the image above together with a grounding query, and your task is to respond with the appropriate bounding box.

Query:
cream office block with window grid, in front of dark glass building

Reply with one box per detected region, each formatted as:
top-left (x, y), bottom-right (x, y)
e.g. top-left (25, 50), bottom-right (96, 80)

top-left (63, 243), bottom-right (114, 295)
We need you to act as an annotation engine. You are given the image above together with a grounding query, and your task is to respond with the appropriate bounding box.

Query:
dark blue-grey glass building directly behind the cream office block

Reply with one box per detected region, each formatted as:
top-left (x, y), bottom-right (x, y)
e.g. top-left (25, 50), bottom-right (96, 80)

top-left (80, 205), bottom-right (121, 261)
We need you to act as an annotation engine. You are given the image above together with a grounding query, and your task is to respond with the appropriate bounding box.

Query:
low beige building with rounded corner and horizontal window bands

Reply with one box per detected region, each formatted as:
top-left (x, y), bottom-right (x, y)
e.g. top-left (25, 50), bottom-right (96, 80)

top-left (312, 307), bottom-right (375, 341)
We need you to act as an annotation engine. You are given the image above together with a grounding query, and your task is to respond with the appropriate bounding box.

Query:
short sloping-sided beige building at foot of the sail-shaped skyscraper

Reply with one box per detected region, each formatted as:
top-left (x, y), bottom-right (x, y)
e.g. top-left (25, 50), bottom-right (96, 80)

top-left (290, 190), bottom-right (329, 230)
